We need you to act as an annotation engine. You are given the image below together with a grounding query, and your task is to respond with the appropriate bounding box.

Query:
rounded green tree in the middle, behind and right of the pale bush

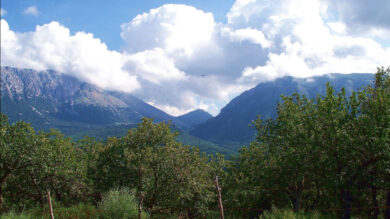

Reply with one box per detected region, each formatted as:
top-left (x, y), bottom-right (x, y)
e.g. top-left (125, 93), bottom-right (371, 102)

top-left (96, 118), bottom-right (215, 217)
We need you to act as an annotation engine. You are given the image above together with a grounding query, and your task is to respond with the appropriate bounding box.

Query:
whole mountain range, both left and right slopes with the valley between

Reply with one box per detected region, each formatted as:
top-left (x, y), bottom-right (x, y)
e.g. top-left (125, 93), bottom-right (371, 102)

top-left (1, 67), bottom-right (373, 154)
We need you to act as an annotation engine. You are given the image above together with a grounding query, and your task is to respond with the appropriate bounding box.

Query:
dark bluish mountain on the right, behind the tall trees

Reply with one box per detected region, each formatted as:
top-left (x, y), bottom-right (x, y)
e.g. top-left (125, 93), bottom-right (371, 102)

top-left (190, 74), bottom-right (374, 150)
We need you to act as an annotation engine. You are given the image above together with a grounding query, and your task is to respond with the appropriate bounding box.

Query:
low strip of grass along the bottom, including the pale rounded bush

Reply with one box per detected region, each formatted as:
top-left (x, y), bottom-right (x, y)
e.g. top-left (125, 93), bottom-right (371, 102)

top-left (0, 201), bottom-right (344, 219)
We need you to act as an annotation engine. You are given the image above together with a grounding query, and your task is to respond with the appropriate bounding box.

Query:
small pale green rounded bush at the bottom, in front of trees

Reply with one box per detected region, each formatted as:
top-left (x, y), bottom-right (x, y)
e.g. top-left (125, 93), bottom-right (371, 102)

top-left (99, 188), bottom-right (146, 219)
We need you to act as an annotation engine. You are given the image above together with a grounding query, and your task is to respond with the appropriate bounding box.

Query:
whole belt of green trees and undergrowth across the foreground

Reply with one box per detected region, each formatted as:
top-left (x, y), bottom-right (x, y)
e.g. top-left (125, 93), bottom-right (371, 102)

top-left (0, 68), bottom-right (390, 218)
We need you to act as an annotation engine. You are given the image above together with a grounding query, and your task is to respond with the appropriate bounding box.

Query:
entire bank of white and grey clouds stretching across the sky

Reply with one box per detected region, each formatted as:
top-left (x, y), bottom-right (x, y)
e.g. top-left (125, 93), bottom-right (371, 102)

top-left (1, 0), bottom-right (390, 115)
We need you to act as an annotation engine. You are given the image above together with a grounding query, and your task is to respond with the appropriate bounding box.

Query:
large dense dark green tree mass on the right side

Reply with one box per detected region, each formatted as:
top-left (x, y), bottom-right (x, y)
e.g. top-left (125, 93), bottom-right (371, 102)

top-left (227, 68), bottom-right (390, 218)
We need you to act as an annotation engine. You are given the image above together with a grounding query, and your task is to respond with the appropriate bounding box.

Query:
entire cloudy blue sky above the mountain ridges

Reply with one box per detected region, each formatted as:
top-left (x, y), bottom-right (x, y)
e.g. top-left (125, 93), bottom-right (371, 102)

top-left (1, 0), bottom-right (390, 116)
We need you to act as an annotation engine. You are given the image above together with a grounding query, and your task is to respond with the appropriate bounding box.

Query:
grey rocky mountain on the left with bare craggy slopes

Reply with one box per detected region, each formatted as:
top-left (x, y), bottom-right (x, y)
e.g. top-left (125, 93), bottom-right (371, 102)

top-left (1, 67), bottom-right (189, 134)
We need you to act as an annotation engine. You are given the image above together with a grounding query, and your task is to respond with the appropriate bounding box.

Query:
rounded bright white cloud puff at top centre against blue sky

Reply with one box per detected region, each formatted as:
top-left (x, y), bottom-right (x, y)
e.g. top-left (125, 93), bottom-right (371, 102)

top-left (121, 4), bottom-right (215, 56)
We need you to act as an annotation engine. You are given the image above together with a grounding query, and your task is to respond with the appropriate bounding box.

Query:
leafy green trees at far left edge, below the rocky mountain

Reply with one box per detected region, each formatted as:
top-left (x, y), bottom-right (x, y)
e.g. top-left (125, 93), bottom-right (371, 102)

top-left (0, 115), bottom-right (86, 208)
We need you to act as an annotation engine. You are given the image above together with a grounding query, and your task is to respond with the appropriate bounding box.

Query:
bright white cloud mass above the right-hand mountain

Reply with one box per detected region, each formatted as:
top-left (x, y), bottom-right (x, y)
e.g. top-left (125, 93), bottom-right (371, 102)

top-left (230, 0), bottom-right (390, 82)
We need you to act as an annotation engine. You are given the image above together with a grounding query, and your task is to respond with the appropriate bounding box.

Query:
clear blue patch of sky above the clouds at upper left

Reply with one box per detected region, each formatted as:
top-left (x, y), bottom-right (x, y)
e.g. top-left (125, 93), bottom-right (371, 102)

top-left (1, 0), bottom-right (234, 50)
